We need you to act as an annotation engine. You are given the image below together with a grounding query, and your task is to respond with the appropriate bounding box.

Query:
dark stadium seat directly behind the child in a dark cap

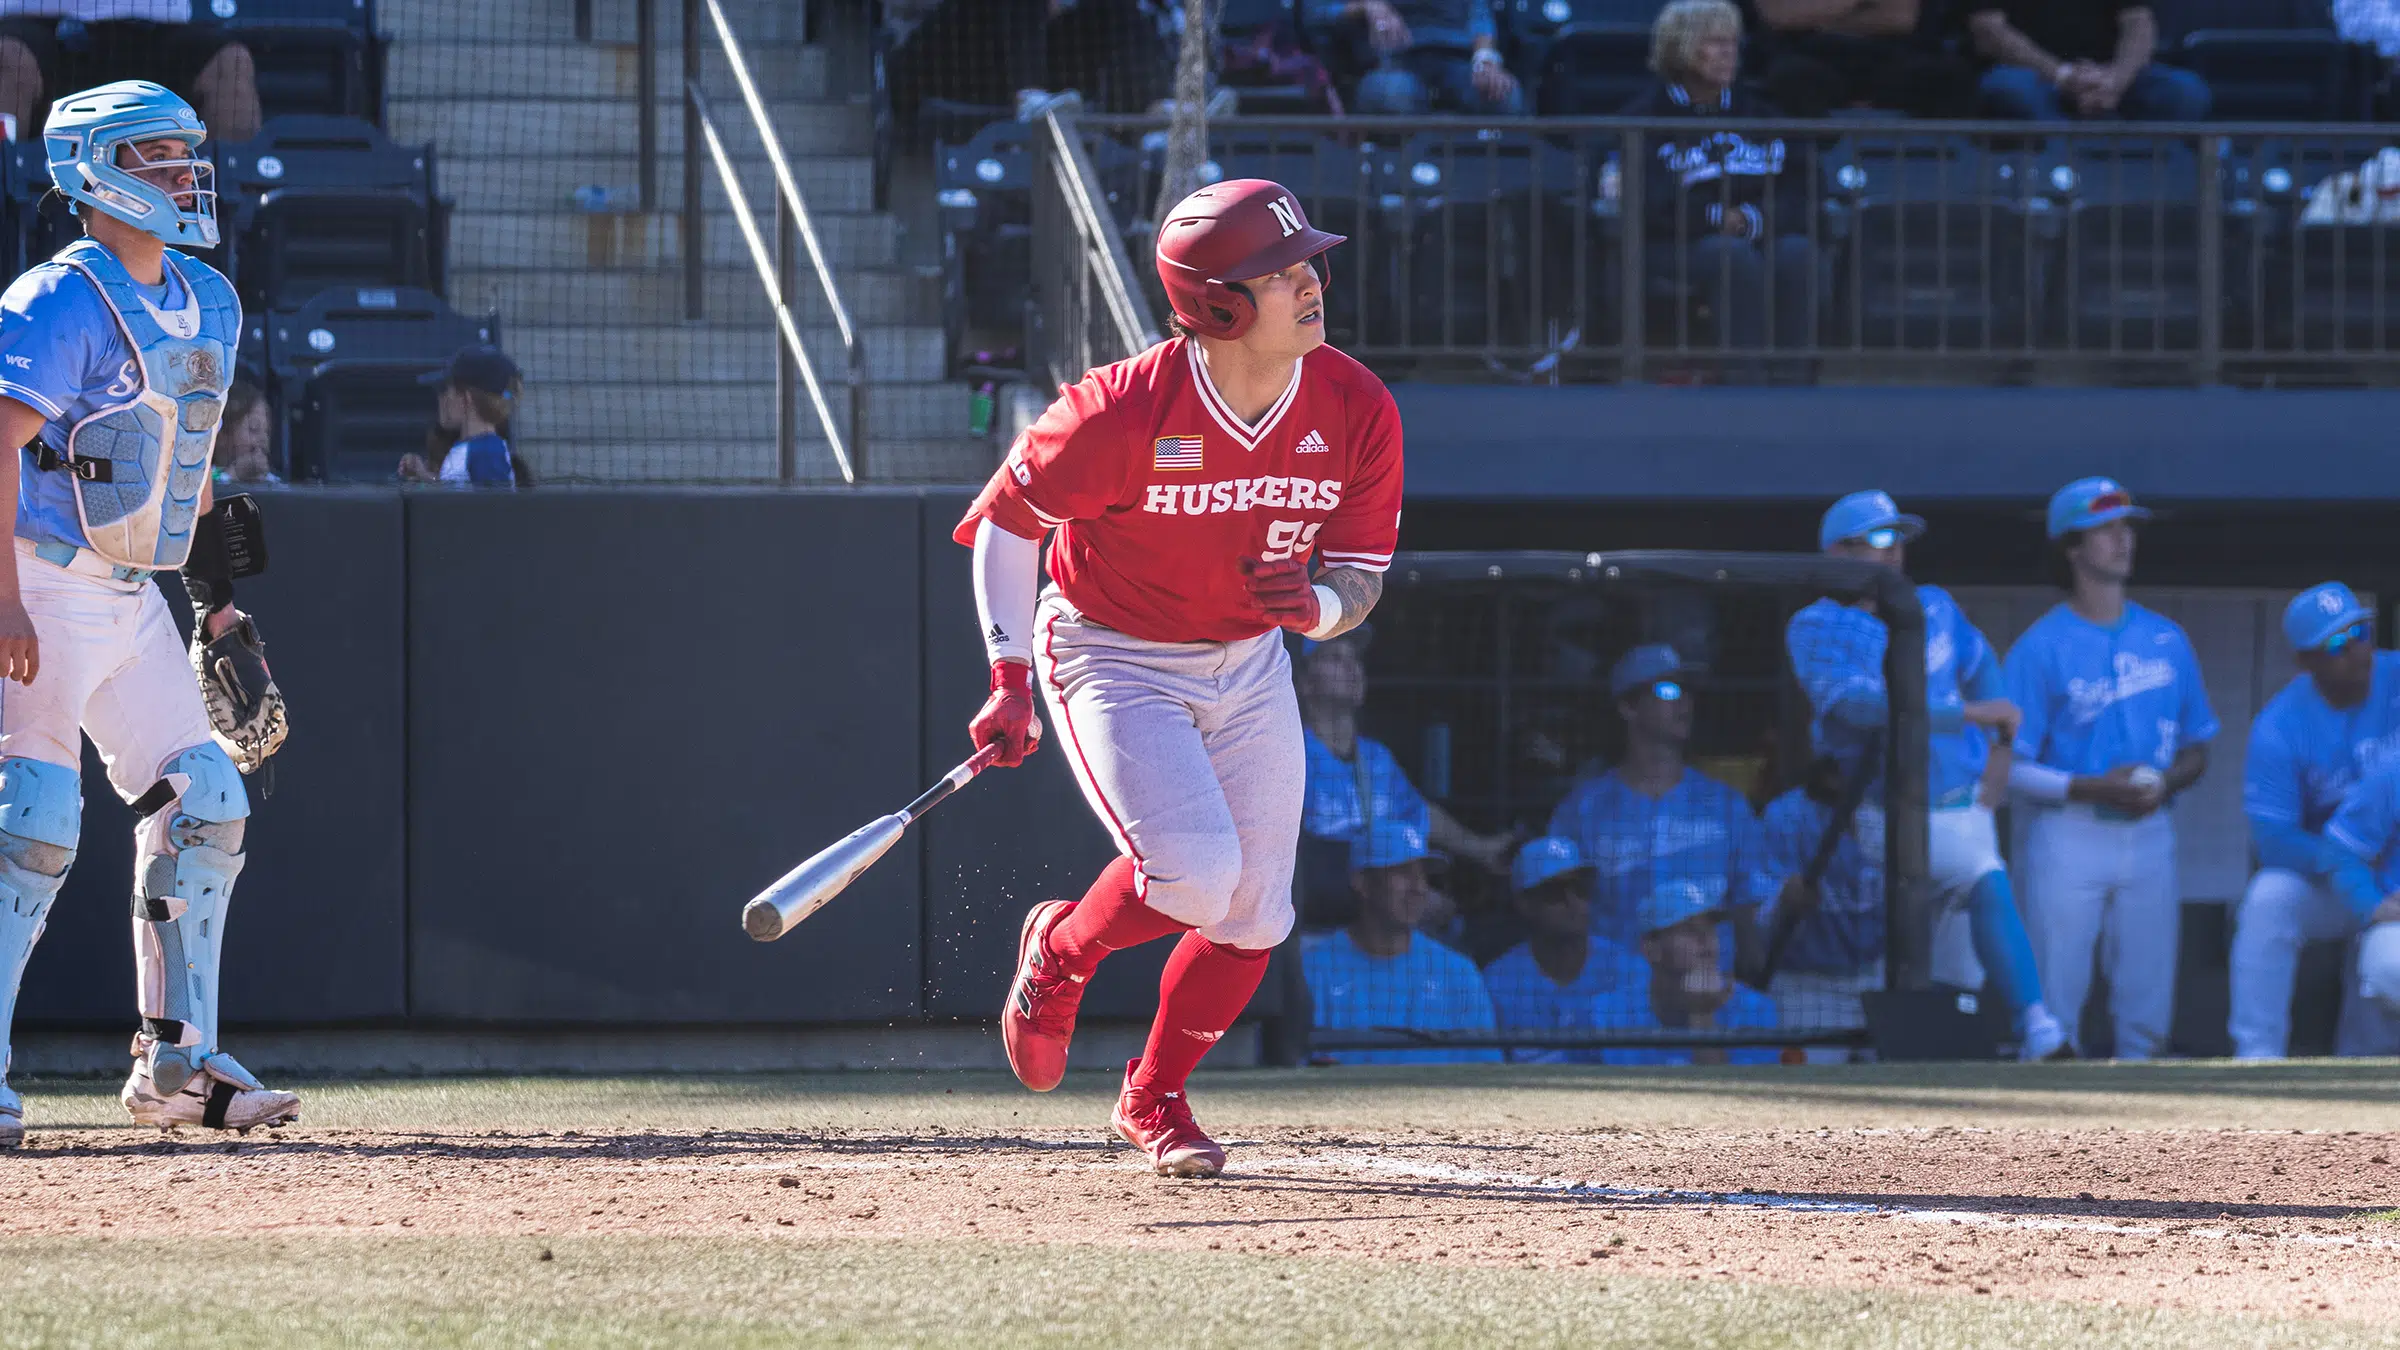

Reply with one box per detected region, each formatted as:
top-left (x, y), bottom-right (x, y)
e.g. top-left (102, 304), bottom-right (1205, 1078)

top-left (266, 288), bottom-right (499, 483)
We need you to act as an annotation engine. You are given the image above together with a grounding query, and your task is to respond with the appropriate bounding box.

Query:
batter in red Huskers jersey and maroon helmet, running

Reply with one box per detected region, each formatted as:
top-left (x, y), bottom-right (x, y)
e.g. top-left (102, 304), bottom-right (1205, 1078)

top-left (955, 178), bottom-right (1402, 1177)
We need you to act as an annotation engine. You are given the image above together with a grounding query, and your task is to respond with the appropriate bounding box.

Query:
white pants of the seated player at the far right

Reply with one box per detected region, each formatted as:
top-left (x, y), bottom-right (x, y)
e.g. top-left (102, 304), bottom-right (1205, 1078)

top-left (2227, 867), bottom-right (2400, 1059)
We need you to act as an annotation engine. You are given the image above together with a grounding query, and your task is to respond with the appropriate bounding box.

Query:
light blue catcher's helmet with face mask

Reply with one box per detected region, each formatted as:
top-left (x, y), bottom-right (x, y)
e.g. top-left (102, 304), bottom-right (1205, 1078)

top-left (41, 79), bottom-right (216, 247)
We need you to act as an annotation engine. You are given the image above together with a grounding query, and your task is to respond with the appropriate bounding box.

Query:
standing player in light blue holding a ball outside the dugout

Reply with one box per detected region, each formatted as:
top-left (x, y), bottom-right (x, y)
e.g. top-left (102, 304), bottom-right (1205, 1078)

top-left (2006, 478), bottom-right (2218, 1059)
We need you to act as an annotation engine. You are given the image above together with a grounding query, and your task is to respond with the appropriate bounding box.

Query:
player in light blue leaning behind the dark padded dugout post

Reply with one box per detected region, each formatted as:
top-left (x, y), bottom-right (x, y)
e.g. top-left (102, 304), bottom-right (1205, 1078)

top-left (1783, 490), bottom-right (2066, 1059)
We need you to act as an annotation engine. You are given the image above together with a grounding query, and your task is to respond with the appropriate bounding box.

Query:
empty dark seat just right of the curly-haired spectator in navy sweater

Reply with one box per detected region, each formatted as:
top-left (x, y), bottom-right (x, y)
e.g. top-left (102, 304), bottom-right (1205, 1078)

top-left (1822, 135), bottom-right (2050, 351)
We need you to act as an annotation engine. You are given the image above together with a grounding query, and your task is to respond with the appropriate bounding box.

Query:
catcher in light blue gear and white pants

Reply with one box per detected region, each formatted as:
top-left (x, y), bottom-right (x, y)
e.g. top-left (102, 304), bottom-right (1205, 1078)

top-left (0, 82), bottom-right (300, 1143)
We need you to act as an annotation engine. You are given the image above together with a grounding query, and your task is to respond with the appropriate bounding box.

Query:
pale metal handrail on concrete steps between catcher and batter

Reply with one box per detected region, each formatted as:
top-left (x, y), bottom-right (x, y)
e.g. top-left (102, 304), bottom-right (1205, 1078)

top-left (684, 0), bottom-right (866, 483)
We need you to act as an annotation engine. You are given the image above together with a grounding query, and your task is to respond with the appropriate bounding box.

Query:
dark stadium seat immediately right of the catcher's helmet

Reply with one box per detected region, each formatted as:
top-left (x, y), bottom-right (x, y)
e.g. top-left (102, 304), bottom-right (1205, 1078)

top-left (218, 115), bottom-right (446, 310)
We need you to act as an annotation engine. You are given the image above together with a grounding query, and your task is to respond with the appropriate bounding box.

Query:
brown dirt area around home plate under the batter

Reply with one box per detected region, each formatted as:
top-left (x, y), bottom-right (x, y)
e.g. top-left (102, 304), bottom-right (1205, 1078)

top-left (0, 1064), bottom-right (2400, 1331)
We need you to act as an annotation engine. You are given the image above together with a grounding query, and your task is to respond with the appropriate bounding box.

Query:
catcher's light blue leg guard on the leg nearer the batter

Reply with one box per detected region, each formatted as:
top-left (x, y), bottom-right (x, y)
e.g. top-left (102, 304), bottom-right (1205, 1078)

top-left (134, 745), bottom-right (250, 1093)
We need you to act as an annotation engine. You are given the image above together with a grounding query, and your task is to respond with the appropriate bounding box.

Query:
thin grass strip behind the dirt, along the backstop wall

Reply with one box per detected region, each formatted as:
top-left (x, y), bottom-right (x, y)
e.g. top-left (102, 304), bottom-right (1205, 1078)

top-left (17, 1059), bottom-right (2400, 1134)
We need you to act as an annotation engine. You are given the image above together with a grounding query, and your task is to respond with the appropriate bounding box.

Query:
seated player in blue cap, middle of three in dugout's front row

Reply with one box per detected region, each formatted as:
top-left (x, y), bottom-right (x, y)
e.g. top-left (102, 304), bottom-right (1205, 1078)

top-left (1483, 834), bottom-right (1634, 1064)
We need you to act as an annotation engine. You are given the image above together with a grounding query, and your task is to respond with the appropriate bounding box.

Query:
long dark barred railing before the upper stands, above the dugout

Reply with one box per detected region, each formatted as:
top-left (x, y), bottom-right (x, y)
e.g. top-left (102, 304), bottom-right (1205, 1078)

top-left (1051, 115), bottom-right (2400, 384)
